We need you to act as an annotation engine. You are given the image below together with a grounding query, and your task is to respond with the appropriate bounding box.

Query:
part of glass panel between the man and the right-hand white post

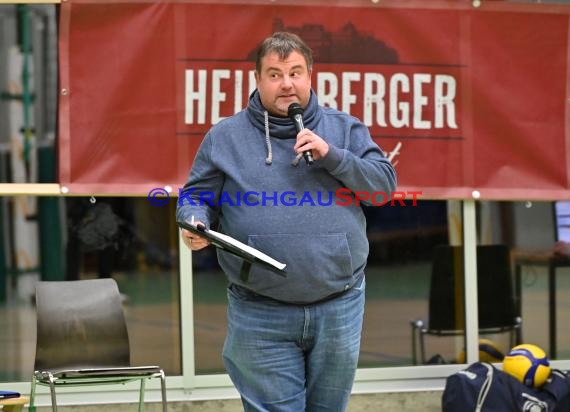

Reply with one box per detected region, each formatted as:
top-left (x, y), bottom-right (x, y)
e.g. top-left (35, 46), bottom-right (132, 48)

top-left (359, 201), bottom-right (463, 367)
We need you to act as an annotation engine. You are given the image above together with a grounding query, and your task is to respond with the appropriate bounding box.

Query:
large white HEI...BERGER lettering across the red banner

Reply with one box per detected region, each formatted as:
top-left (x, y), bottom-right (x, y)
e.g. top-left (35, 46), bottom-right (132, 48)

top-left (184, 69), bottom-right (458, 130)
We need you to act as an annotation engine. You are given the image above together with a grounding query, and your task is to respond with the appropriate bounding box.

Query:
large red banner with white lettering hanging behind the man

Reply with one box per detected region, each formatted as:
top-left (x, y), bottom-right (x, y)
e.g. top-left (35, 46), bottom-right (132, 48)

top-left (59, 0), bottom-right (570, 199)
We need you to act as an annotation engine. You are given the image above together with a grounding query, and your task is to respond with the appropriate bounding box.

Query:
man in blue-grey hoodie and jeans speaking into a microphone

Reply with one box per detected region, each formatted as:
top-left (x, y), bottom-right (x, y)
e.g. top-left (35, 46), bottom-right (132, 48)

top-left (177, 33), bottom-right (396, 412)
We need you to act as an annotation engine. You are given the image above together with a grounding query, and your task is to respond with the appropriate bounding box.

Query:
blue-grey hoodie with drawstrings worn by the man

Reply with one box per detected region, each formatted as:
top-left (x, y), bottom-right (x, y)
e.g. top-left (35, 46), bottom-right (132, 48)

top-left (176, 91), bottom-right (396, 304)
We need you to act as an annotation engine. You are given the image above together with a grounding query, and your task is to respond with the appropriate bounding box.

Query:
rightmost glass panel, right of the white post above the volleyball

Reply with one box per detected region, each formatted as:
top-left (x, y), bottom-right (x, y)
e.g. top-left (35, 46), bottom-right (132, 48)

top-left (478, 201), bottom-right (570, 359)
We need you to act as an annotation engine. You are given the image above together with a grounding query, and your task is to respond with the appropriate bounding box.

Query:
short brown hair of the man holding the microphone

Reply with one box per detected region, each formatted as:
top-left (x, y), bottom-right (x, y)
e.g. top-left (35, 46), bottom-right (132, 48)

top-left (255, 32), bottom-right (313, 73)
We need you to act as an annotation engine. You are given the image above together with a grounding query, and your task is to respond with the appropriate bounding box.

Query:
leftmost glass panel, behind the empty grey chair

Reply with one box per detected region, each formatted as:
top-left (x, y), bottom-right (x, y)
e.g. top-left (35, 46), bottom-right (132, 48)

top-left (0, 196), bottom-right (181, 381)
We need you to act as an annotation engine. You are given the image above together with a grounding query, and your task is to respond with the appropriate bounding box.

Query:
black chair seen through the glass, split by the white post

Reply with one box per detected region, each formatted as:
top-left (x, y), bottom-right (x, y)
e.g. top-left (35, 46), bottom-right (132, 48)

top-left (411, 245), bottom-right (521, 364)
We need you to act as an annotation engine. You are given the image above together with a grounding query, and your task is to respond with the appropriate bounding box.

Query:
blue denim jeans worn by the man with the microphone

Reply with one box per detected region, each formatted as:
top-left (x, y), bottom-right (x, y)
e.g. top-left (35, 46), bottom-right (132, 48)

top-left (223, 280), bottom-right (365, 412)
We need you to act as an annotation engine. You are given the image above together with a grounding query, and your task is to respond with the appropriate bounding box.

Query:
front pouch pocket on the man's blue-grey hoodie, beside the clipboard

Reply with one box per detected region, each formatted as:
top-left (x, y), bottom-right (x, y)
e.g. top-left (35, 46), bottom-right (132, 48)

top-left (248, 233), bottom-right (353, 287)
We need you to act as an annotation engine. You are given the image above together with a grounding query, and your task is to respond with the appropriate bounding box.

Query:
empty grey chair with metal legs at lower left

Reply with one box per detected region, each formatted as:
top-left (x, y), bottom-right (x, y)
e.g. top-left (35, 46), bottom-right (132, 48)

top-left (30, 279), bottom-right (167, 412)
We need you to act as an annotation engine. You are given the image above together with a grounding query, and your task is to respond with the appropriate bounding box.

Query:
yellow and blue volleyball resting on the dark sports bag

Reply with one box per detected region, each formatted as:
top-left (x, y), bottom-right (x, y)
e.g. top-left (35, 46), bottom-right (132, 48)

top-left (503, 344), bottom-right (551, 388)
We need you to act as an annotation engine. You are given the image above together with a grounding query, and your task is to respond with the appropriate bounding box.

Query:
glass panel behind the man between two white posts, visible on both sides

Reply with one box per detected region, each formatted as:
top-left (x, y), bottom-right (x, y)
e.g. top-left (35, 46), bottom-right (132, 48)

top-left (192, 201), bottom-right (463, 374)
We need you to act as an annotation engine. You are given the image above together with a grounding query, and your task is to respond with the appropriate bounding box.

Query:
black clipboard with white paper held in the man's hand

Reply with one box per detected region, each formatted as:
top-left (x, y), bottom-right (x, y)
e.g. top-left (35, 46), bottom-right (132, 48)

top-left (176, 221), bottom-right (287, 280)
